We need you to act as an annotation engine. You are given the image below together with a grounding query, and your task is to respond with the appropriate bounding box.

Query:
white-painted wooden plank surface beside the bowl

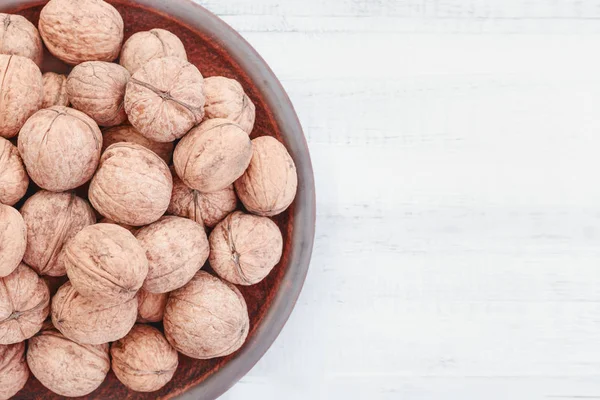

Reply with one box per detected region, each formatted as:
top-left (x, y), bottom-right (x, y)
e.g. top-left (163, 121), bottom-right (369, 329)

top-left (193, 0), bottom-right (600, 400)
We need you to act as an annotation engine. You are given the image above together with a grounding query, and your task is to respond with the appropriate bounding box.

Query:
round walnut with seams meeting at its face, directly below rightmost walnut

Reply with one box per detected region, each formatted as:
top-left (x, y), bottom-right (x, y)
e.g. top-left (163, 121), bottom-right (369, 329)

top-left (209, 211), bottom-right (283, 285)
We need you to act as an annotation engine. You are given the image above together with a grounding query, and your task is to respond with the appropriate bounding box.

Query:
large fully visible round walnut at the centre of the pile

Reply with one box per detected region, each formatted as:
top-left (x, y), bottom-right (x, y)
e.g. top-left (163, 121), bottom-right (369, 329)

top-left (89, 142), bottom-right (173, 226)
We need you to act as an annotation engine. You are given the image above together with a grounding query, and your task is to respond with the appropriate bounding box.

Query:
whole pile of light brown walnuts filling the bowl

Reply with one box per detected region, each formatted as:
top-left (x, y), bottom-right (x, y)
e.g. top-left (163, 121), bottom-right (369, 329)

top-left (0, 0), bottom-right (298, 398)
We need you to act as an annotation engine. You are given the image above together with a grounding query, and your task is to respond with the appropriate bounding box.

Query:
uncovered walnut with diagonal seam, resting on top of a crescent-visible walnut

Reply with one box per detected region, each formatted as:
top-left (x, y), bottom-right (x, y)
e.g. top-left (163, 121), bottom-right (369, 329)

top-left (64, 224), bottom-right (148, 304)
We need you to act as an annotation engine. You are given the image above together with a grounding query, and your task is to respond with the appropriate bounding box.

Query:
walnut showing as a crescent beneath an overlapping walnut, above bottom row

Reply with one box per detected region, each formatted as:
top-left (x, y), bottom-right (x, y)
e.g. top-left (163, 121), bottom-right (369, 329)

top-left (51, 282), bottom-right (137, 344)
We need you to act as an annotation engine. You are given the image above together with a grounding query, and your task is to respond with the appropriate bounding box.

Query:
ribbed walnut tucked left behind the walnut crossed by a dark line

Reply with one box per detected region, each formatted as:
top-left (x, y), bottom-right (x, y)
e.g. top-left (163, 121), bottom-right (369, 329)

top-left (67, 61), bottom-right (130, 126)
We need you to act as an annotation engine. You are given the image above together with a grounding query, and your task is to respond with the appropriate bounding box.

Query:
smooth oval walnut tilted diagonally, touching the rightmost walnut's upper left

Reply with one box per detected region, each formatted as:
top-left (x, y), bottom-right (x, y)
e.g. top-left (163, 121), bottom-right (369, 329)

top-left (173, 118), bottom-right (252, 193)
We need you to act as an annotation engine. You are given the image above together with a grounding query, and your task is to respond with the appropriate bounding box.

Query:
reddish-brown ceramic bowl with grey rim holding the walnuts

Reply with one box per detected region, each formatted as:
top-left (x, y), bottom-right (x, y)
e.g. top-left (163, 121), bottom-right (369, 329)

top-left (0, 0), bottom-right (315, 400)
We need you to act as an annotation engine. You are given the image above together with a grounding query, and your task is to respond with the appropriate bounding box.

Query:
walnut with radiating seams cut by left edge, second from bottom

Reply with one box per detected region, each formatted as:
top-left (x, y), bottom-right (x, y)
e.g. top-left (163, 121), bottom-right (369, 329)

top-left (0, 263), bottom-right (50, 344)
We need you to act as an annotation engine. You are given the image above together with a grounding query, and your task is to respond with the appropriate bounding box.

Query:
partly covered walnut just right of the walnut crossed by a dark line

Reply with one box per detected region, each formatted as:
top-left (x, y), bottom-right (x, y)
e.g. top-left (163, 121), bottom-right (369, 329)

top-left (204, 76), bottom-right (256, 134)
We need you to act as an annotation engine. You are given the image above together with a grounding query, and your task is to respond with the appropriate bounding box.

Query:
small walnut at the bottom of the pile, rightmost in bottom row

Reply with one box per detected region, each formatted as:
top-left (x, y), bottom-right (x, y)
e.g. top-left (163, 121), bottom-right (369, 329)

top-left (110, 325), bottom-right (179, 392)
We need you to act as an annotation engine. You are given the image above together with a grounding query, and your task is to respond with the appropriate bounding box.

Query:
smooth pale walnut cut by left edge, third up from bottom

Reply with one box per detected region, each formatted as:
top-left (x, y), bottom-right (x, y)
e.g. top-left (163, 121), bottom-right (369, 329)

top-left (0, 204), bottom-right (27, 277)
